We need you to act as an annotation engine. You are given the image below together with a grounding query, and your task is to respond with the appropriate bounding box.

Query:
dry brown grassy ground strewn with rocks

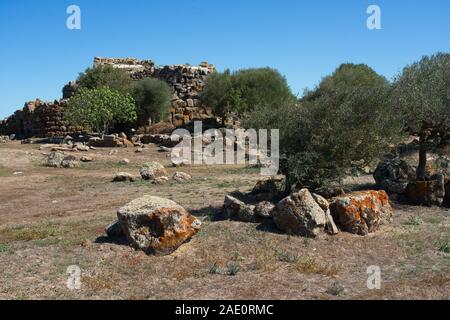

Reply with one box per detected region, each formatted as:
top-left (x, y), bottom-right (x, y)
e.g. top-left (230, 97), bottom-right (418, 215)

top-left (0, 142), bottom-right (450, 299)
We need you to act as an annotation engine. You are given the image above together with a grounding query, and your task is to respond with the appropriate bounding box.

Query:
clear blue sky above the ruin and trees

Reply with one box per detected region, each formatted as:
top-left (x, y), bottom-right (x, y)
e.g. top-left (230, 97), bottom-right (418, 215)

top-left (0, 0), bottom-right (450, 118)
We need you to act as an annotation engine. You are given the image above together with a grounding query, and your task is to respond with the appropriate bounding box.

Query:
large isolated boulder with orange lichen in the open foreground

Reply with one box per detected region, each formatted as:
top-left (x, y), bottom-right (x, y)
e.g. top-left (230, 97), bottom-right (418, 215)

top-left (117, 195), bottom-right (201, 255)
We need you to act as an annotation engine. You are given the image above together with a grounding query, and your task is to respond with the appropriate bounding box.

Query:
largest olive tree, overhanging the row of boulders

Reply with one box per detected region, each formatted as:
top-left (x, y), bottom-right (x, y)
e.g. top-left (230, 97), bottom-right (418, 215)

top-left (245, 64), bottom-right (403, 190)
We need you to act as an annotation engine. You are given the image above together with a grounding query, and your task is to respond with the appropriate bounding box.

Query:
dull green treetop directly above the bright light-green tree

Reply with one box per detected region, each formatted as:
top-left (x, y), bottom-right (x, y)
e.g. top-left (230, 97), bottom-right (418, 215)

top-left (77, 65), bottom-right (132, 93)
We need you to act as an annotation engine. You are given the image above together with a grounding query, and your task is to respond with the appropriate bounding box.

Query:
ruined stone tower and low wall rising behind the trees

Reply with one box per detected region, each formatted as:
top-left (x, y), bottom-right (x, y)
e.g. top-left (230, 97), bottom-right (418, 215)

top-left (0, 57), bottom-right (216, 137)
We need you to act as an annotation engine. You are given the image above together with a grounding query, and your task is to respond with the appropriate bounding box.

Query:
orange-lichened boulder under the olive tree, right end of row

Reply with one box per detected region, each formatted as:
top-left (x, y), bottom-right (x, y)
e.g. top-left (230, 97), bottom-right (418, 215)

top-left (330, 191), bottom-right (393, 235)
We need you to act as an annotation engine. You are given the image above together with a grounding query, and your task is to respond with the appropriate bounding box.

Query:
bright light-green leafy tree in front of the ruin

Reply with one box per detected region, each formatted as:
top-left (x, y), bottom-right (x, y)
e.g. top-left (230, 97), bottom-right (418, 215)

top-left (64, 88), bottom-right (137, 134)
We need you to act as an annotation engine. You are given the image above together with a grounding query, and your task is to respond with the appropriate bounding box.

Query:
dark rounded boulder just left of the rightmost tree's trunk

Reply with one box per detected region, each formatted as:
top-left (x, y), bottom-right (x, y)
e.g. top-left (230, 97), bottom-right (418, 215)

top-left (373, 158), bottom-right (416, 194)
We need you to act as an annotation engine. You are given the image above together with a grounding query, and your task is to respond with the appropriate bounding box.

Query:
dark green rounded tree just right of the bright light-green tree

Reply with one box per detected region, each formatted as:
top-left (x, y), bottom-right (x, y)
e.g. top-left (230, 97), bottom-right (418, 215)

top-left (133, 78), bottom-right (172, 125)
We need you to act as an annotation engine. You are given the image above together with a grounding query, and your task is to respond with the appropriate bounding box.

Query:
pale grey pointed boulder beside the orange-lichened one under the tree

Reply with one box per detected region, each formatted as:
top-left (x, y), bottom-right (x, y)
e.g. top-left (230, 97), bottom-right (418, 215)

top-left (273, 189), bottom-right (327, 237)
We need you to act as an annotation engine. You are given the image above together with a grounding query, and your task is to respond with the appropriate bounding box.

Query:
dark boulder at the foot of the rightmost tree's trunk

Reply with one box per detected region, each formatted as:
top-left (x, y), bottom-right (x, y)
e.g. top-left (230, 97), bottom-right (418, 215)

top-left (405, 174), bottom-right (445, 207)
